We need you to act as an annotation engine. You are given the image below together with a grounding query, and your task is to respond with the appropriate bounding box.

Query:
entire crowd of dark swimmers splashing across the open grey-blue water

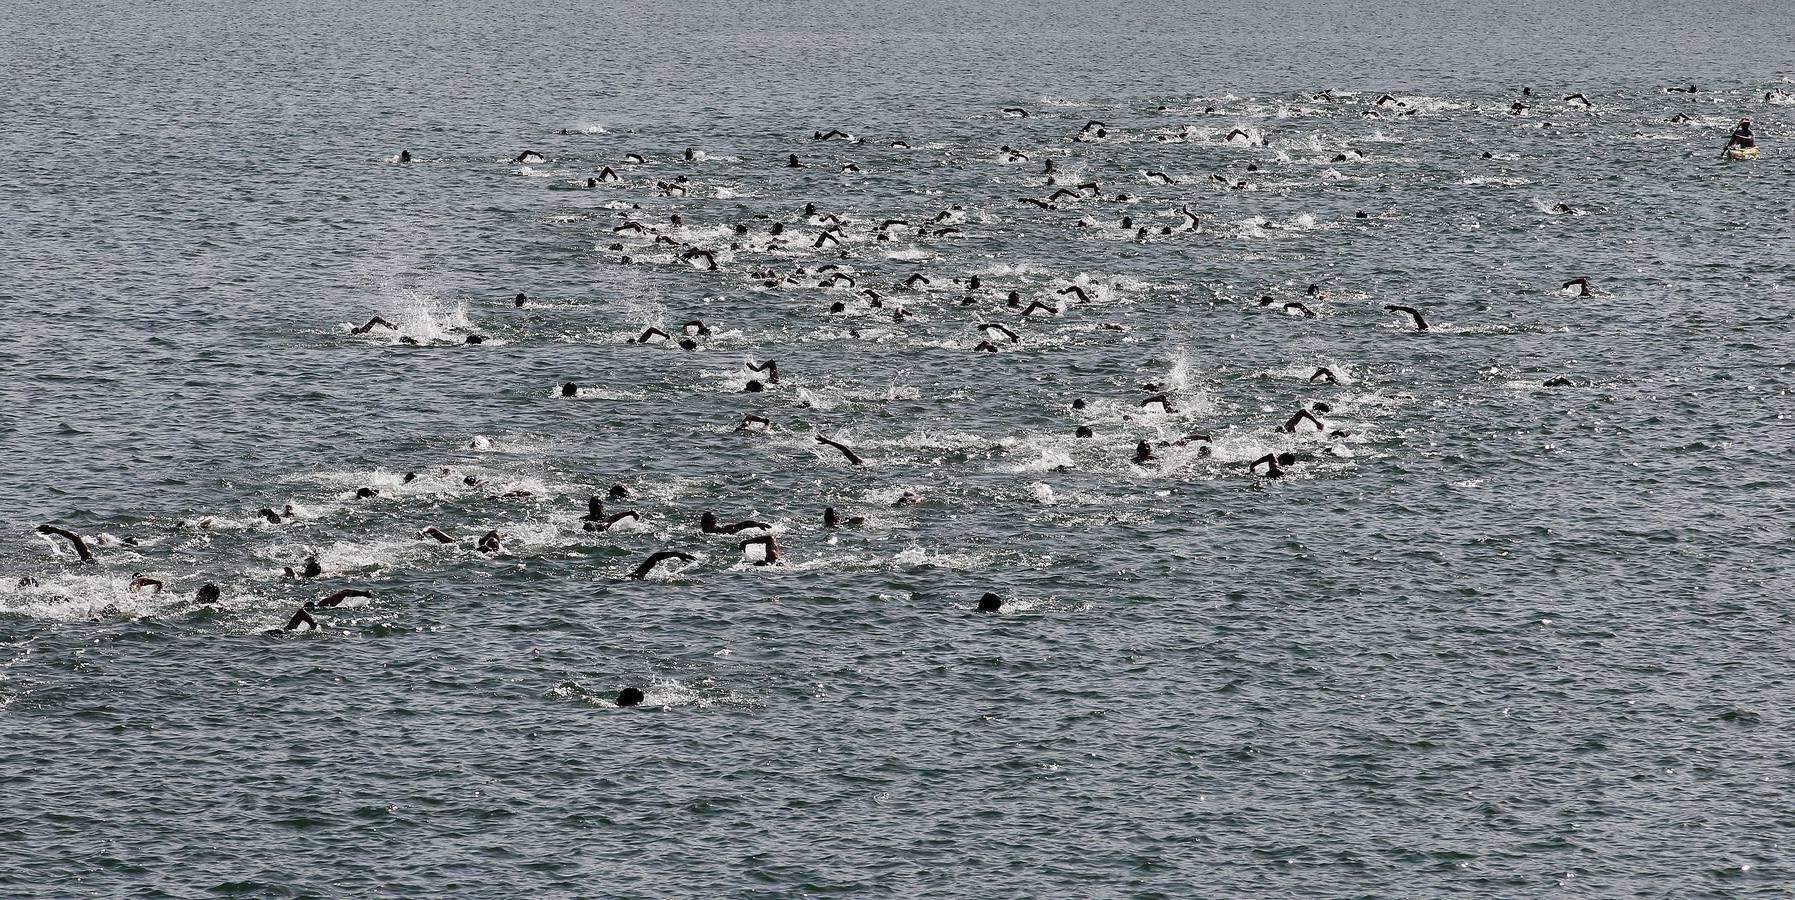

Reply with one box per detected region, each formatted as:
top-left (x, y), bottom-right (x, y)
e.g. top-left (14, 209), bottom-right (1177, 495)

top-left (27, 86), bottom-right (1757, 708)
